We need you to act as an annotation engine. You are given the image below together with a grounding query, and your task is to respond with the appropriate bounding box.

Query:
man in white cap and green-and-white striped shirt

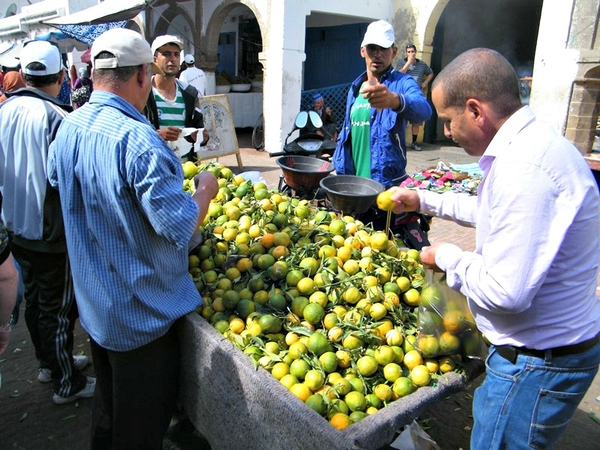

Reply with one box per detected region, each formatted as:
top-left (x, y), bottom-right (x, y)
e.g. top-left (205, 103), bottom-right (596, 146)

top-left (145, 35), bottom-right (208, 161)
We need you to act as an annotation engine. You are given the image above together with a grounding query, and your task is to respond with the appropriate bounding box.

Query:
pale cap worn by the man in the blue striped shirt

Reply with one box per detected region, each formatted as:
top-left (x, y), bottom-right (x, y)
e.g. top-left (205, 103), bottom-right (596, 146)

top-left (90, 28), bottom-right (162, 73)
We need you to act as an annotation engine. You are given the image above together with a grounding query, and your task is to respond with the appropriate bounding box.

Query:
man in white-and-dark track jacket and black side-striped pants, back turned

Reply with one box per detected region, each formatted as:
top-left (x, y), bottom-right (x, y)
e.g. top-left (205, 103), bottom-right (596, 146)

top-left (0, 41), bottom-right (95, 405)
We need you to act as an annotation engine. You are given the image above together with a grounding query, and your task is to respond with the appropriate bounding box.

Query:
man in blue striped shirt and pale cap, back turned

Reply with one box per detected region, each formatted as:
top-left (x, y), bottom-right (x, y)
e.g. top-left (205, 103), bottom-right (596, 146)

top-left (48, 28), bottom-right (218, 450)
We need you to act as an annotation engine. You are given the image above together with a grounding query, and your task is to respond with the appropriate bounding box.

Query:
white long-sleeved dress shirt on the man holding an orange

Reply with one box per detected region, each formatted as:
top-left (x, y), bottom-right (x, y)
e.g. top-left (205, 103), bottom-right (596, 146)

top-left (419, 106), bottom-right (600, 350)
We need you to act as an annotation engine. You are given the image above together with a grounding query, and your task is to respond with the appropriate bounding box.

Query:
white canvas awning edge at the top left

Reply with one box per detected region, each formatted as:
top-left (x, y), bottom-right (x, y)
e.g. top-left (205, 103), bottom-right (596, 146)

top-left (44, 0), bottom-right (153, 25)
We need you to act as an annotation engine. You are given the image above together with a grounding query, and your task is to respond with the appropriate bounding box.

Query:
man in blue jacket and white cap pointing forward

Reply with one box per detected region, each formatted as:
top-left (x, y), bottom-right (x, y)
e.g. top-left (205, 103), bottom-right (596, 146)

top-left (333, 20), bottom-right (432, 245)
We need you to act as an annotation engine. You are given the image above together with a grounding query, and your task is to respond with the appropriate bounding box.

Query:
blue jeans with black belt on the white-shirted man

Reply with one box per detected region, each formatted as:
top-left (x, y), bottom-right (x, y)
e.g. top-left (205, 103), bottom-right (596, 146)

top-left (471, 343), bottom-right (600, 450)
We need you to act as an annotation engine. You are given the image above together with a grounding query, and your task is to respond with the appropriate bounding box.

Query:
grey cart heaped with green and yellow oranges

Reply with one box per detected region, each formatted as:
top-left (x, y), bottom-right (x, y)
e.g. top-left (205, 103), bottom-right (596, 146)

top-left (179, 162), bottom-right (485, 449)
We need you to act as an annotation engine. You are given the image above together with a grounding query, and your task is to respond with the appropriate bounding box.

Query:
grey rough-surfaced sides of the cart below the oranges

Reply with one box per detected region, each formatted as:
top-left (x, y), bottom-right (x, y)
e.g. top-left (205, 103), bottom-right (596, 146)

top-left (179, 314), bottom-right (482, 450)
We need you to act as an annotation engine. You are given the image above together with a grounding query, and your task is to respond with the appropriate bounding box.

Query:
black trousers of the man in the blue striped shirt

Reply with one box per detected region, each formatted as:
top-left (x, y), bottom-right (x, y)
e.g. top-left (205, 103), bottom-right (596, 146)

top-left (92, 327), bottom-right (180, 450)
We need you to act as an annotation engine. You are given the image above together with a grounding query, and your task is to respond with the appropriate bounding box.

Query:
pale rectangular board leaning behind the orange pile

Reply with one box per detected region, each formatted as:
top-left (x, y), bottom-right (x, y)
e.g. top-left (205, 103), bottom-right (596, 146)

top-left (196, 95), bottom-right (242, 170)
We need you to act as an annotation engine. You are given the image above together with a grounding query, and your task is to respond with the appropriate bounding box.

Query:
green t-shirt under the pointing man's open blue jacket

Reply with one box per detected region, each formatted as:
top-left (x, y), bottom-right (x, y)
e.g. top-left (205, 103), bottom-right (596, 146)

top-left (350, 87), bottom-right (371, 178)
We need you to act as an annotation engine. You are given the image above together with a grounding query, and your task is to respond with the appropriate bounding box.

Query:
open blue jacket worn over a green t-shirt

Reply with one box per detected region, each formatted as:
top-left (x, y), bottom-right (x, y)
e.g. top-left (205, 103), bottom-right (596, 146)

top-left (333, 66), bottom-right (432, 189)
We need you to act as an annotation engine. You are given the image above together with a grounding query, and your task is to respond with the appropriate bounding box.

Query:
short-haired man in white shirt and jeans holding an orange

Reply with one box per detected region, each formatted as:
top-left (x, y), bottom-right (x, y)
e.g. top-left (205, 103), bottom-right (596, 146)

top-left (392, 48), bottom-right (600, 449)
